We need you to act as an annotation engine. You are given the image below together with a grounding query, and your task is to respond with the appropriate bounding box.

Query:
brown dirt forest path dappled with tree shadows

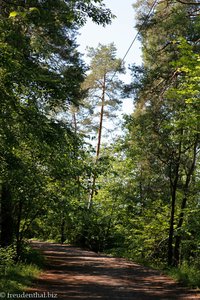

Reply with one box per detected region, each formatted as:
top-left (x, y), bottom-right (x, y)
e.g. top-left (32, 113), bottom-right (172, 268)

top-left (28, 242), bottom-right (200, 300)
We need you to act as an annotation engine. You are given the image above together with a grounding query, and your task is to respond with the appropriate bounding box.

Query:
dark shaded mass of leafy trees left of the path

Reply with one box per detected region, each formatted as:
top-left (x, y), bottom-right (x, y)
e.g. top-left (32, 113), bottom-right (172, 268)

top-left (0, 0), bottom-right (112, 254)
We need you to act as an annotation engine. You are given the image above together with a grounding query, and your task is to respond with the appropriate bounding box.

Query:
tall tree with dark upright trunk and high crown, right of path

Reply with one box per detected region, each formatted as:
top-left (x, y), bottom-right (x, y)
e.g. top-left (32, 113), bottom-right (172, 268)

top-left (123, 1), bottom-right (200, 266)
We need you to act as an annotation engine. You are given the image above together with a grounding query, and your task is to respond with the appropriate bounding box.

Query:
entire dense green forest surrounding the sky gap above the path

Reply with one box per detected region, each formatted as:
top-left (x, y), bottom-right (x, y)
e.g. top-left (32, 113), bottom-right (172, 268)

top-left (0, 0), bottom-right (200, 284)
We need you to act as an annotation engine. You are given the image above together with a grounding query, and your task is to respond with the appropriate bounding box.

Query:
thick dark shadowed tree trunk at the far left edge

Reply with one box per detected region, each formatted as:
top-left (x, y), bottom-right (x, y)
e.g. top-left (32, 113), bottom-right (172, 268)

top-left (0, 183), bottom-right (13, 247)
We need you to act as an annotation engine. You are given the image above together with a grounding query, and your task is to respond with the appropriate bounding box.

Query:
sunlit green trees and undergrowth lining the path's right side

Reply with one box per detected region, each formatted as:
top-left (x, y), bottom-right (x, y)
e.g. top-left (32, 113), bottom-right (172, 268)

top-left (72, 1), bottom-right (200, 267)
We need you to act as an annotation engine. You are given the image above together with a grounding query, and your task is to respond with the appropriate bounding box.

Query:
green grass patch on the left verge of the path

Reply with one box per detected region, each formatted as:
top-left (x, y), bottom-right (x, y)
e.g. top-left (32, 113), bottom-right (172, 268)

top-left (0, 244), bottom-right (44, 295)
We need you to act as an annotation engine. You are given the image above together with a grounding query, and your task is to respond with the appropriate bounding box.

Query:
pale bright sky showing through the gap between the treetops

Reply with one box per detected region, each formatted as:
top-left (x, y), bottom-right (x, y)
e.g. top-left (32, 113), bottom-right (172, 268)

top-left (77, 0), bottom-right (141, 119)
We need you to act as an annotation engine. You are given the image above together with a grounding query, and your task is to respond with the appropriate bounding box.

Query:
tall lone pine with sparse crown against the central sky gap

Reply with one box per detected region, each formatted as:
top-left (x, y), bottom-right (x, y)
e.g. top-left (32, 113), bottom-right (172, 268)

top-left (74, 43), bottom-right (124, 208)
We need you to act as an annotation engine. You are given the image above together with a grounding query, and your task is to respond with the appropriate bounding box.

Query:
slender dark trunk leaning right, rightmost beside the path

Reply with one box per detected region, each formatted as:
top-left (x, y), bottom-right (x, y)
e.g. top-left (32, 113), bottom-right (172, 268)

top-left (174, 136), bottom-right (199, 266)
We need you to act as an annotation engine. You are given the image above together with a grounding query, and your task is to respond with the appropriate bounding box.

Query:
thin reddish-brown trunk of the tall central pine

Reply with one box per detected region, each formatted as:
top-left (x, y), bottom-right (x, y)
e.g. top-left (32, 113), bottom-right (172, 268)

top-left (88, 75), bottom-right (106, 209)
